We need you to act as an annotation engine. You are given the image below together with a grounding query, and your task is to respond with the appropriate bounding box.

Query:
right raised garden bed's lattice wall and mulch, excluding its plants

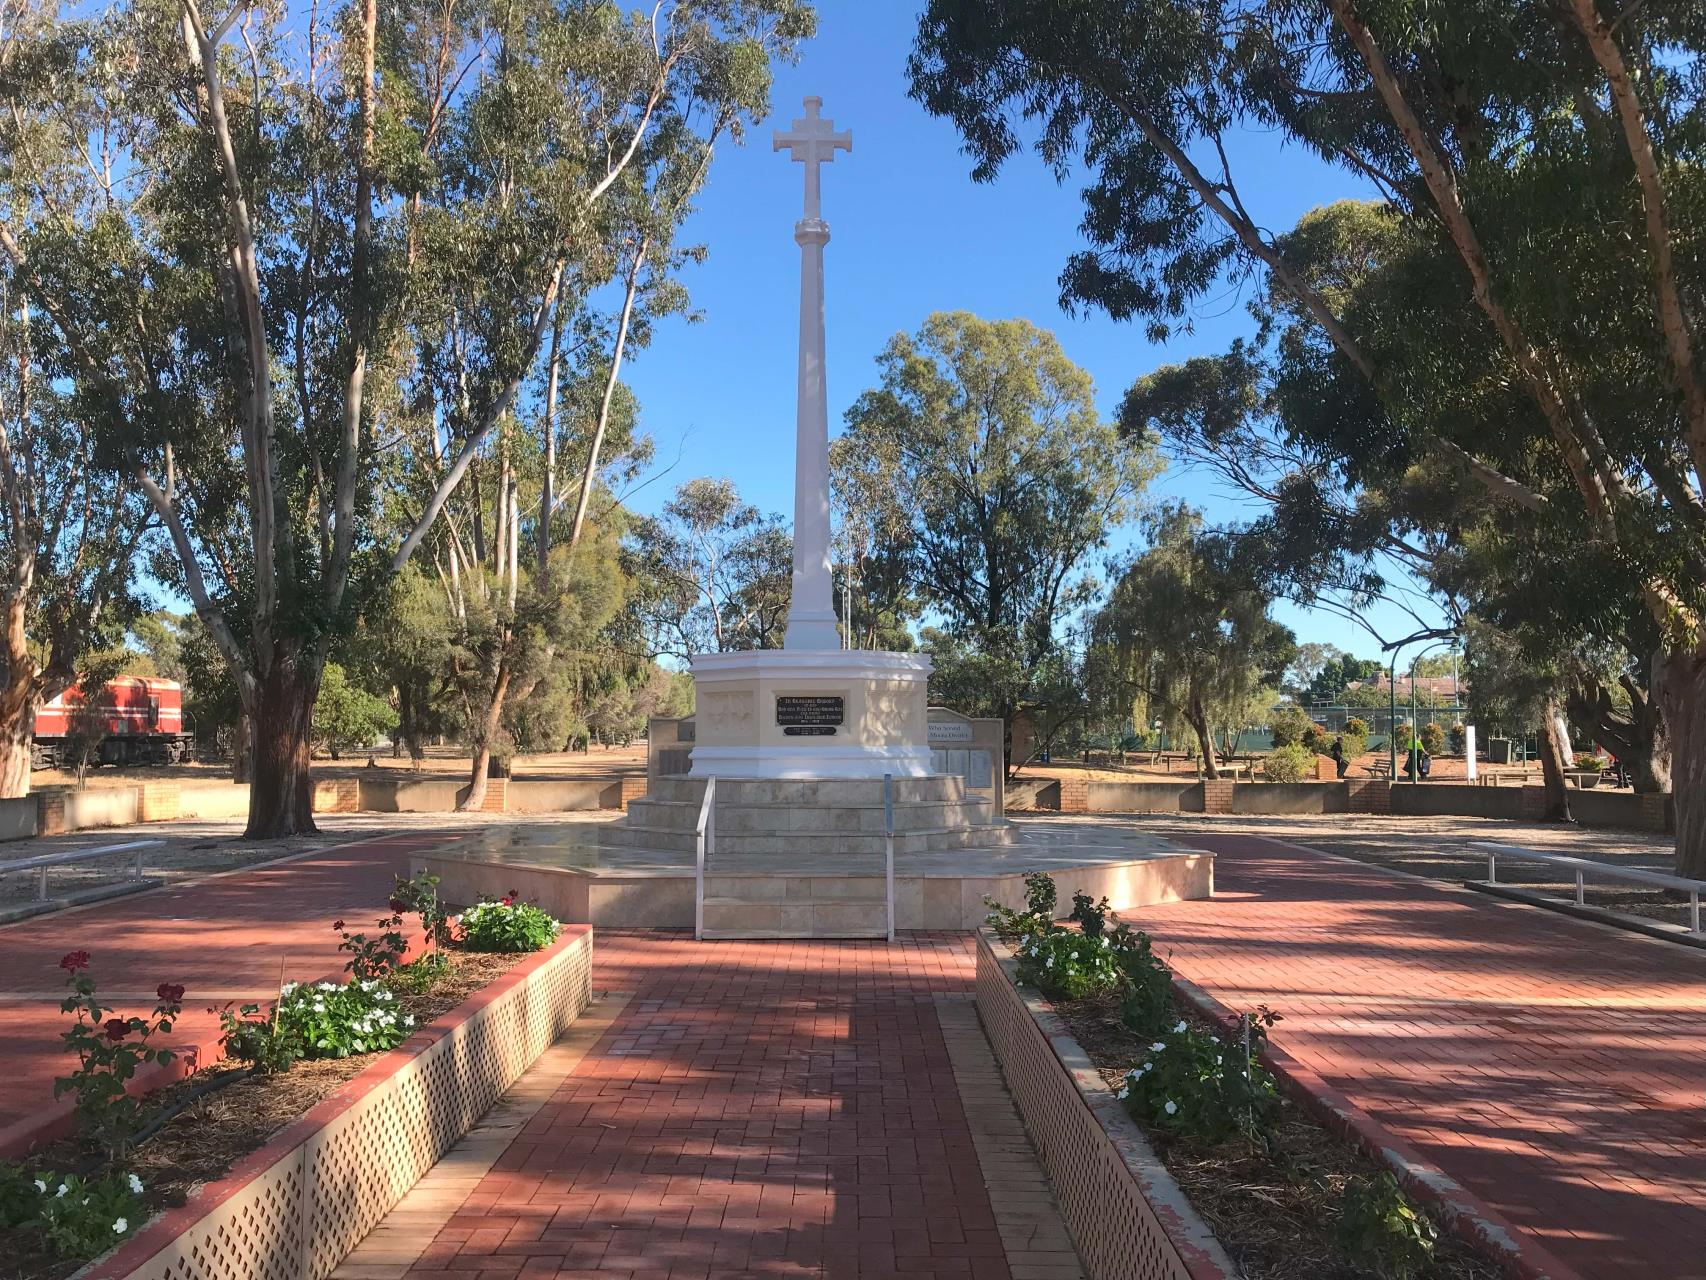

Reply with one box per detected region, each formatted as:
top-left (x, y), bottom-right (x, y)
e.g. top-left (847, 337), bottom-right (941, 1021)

top-left (978, 932), bottom-right (1506, 1280)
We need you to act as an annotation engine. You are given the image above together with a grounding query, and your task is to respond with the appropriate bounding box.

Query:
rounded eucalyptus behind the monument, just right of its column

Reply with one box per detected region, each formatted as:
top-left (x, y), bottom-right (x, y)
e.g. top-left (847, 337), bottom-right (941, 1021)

top-left (834, 312), bottom-right (1158, 720)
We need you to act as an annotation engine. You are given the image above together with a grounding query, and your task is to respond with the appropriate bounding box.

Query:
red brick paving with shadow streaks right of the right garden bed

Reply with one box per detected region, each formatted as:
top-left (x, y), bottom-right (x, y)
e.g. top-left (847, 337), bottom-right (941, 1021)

top-left (1132, 831), bottom-right (1706, 1280)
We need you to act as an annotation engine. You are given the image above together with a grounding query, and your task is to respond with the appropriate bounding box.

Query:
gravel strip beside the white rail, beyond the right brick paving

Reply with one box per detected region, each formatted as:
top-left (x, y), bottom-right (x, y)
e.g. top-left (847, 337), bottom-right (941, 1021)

top-left (1105, 814), bottom-right (1687, 925)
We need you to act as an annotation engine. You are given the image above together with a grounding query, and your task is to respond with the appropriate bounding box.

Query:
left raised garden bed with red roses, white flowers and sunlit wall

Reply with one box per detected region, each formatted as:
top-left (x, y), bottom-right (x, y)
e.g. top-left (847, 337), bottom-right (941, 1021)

top-left (0, 877), bottom-right (592, 1280)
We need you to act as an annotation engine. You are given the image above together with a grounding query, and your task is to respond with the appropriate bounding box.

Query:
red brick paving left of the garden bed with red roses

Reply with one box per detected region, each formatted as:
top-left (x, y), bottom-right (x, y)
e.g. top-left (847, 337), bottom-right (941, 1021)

top-left (0, 833), bottom-right (457, 1152)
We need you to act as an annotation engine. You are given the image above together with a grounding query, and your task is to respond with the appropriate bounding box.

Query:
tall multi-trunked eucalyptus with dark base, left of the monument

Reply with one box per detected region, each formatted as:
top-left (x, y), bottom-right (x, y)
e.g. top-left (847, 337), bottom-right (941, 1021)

top-left (0, 0), bottom-right (810, 836)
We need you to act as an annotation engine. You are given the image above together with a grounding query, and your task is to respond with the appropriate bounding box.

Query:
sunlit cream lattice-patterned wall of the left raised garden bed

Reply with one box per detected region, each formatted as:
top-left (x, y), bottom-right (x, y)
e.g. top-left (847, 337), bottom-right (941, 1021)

top-left (95, 927), bottom-right (592, 1280)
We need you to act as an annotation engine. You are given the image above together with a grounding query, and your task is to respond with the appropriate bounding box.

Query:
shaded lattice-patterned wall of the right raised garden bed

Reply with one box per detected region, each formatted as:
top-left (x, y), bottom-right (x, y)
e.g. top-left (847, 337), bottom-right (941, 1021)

top-left (978, 930), bottom-right (1239, 1280)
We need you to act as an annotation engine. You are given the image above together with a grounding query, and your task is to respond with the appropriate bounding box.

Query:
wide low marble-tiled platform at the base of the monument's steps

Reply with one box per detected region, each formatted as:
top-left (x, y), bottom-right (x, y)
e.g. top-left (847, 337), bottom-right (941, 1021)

top-left (415, 817), bottom-right (1213, 937)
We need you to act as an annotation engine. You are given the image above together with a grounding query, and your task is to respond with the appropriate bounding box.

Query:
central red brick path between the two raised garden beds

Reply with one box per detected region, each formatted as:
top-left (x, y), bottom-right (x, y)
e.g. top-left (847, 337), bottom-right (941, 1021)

top-left (409, 932), bottom-right (1010, 1280)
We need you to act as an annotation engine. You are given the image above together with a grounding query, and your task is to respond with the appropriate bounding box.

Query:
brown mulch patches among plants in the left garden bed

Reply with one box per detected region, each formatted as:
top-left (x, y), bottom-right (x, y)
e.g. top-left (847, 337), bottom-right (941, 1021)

top-left (0, 951), bottom-right (524, 1280)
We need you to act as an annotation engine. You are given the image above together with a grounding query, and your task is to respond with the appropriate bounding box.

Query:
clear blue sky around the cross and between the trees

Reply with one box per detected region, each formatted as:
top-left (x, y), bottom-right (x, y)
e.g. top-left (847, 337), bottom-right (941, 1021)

top-left (628, 0), bottom-right (1453, 654)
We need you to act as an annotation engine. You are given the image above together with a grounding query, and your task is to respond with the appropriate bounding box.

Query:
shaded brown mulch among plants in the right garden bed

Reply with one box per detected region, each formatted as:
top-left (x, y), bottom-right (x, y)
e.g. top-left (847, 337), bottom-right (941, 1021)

top-left (1054, 997), bottom-right (1501, 1280)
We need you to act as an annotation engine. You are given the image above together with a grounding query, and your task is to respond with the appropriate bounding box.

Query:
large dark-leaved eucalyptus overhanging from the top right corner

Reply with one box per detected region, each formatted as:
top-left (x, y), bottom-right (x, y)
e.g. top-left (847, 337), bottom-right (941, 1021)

top-left (913, 0), bottom-right (1706, 874)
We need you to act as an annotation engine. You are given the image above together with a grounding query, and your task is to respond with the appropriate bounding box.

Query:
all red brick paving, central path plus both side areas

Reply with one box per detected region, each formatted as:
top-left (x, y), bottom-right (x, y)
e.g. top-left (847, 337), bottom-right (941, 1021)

top-left (0, 817), bottom-right (1706, 1280)
